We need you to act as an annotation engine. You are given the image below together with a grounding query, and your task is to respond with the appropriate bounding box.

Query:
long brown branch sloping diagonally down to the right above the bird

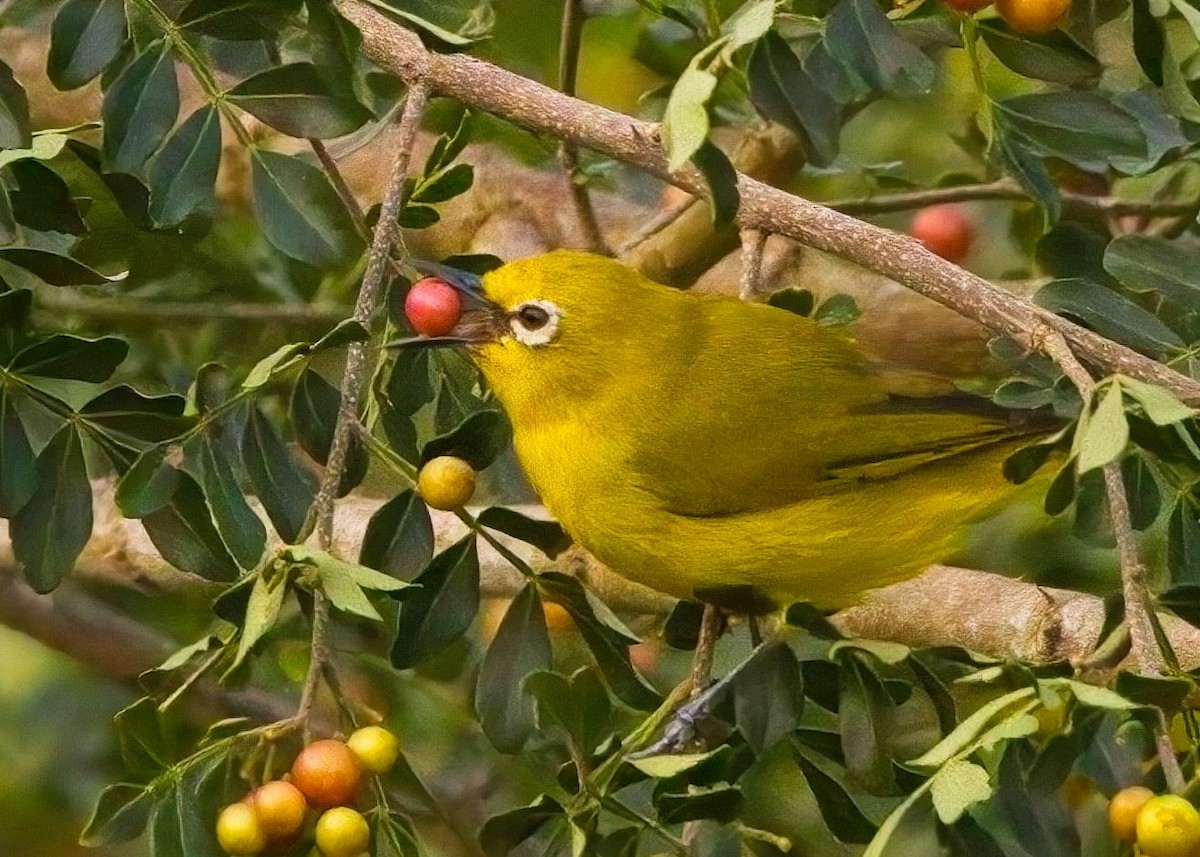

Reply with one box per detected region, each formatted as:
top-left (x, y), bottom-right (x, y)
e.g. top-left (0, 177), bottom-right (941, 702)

top-left (335, 0), bottom-right (1200, 404)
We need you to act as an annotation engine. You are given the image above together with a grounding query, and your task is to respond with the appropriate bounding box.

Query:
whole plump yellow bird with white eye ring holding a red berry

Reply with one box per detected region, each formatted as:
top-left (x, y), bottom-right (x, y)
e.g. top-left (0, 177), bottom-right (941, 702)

top-left (415, 251), bottom-right (1051, 612)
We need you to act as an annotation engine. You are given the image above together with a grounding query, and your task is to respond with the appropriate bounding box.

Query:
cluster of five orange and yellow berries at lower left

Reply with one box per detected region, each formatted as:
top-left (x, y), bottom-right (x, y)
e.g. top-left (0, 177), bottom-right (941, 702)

top-left (217, 726), bottom-right (400, 857)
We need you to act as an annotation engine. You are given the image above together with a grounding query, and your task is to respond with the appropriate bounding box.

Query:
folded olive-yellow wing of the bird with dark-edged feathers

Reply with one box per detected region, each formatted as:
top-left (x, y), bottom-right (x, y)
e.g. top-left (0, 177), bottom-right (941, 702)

top-left (624, 299), bottom-right (1027, 516)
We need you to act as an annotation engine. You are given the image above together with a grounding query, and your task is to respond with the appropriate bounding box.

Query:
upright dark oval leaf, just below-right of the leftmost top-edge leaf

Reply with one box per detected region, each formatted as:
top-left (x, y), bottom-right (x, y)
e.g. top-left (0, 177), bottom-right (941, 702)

top-left (102, 40), bottom-right (179, 174)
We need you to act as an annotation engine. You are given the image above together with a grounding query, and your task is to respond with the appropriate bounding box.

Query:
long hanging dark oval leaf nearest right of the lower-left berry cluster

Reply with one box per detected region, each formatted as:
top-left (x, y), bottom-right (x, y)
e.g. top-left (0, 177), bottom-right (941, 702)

top-left (475, 583), bottom-right (551, 753)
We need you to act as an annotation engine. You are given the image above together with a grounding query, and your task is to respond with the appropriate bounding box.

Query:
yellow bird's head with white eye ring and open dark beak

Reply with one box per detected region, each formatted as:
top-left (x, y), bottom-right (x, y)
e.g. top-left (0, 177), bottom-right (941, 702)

top-left (400, 250), bottom-right (672, 424)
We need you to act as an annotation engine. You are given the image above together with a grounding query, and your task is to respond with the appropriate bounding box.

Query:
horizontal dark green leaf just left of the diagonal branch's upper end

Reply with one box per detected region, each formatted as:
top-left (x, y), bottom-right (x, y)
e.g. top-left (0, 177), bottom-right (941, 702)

top-left (226, 62), bottom-right (373, 138)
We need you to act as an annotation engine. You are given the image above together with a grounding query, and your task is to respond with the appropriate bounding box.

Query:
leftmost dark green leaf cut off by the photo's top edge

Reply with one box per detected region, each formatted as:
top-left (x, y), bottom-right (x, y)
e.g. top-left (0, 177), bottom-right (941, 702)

top-left (46, 0), bottom-right (126, 89)
